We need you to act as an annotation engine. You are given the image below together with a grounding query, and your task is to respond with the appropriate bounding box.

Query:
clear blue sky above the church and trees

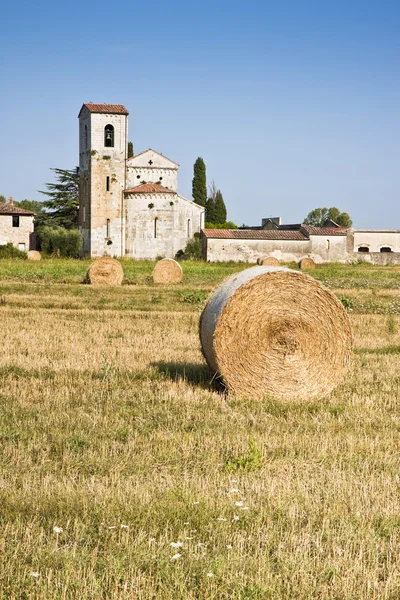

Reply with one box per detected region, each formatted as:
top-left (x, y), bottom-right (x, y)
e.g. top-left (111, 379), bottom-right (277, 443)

top-left (0, 0), bottom-right (400, 229)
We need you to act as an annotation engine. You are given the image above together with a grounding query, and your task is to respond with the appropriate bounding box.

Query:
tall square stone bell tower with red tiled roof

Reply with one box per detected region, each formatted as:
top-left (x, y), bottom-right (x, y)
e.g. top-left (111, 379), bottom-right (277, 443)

top-left (78, 103), bottom-right (129, 257)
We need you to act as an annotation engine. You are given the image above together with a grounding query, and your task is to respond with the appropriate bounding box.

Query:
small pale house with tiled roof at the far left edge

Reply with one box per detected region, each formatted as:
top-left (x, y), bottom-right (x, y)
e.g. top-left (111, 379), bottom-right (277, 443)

top-left (0, 198), bottom-right (34, 251)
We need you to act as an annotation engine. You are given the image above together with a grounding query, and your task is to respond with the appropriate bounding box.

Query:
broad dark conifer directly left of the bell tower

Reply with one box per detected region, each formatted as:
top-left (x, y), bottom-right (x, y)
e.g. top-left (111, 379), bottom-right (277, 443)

top-left (39, 167), bottom-right (79, 229)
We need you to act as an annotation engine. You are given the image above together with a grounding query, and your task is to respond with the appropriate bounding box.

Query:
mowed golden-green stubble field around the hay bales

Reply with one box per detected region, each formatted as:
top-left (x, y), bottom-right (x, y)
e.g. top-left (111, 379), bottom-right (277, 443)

top-left (0, 260), bottom-right (400, 600)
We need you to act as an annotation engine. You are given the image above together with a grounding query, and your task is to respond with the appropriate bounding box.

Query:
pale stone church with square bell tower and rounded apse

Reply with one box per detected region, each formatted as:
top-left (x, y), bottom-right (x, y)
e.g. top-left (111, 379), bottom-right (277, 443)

top-left (78, 103), bottom-right (204, 259)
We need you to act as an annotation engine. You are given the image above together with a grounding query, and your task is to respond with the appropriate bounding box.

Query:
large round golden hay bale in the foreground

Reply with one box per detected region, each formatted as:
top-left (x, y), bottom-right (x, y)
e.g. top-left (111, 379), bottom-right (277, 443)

top-left (200, 266), bottom-right (352, 400)
